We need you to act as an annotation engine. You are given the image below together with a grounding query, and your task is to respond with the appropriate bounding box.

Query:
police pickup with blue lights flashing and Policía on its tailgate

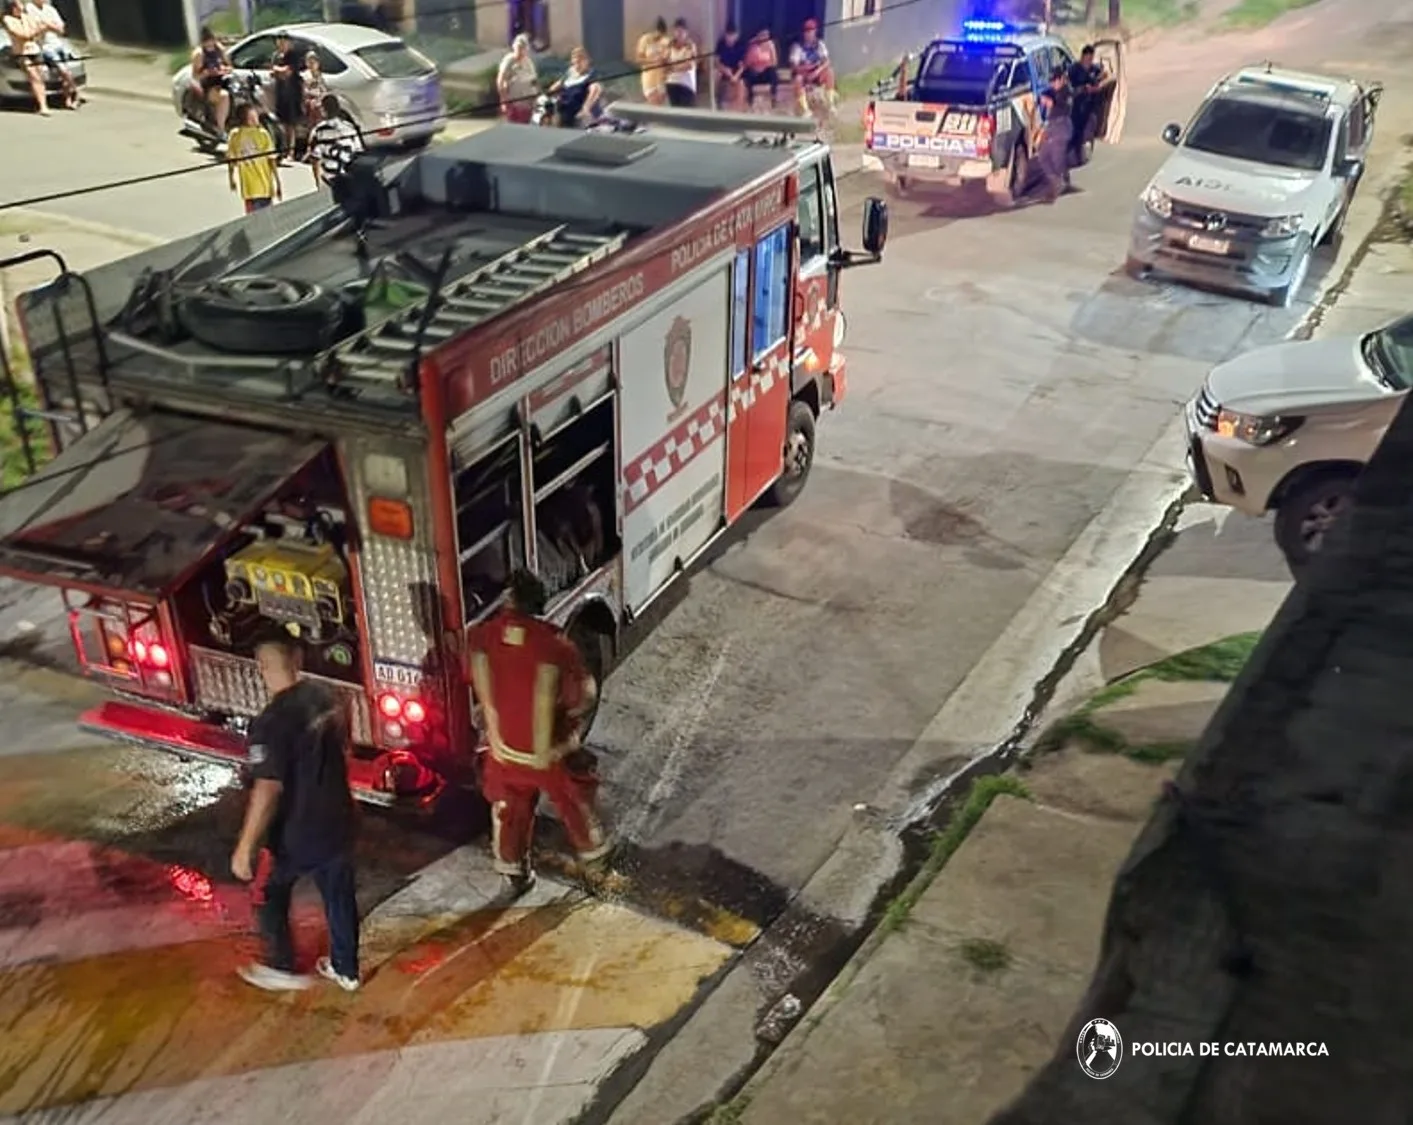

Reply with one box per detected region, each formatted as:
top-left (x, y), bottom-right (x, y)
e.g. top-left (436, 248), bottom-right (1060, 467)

top-left (863, 20), bottom-right (1125, 206)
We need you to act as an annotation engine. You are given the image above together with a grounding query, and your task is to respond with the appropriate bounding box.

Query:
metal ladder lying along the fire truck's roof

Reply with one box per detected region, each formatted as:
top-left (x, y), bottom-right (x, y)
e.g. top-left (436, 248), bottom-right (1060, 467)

top-left (326, 223), bottom-right (629, 386)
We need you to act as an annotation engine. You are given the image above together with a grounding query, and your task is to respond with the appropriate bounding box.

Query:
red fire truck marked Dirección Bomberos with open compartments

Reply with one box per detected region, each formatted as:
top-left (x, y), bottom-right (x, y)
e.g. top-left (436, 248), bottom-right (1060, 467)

top-left (0, 110), bottom-right (887, 803)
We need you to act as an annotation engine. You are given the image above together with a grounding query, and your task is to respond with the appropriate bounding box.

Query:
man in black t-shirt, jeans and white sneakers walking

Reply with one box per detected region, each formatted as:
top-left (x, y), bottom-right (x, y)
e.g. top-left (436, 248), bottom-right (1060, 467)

top-left (230, 633), bottom-right (359, 992)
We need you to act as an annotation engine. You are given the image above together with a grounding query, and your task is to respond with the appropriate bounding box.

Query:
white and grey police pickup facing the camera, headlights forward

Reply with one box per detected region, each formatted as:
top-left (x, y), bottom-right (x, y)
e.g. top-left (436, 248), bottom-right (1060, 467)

top-left (1126, 64), bottom-right (1382, 307)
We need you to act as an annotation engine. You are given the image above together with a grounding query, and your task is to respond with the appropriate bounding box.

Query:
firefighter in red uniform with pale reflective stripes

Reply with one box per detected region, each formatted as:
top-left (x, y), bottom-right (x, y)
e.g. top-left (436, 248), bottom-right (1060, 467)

top-left (466, 571), bottom-right (610, 893)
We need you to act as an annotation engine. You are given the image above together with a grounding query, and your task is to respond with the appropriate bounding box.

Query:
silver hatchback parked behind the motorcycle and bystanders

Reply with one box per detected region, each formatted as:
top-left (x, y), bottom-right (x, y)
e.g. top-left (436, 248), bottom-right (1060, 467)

top-left (172, 24), bottom-right (447, 147)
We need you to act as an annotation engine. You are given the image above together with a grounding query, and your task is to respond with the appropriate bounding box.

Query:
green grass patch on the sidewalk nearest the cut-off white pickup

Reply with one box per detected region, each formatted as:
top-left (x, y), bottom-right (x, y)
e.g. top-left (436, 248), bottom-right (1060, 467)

top-left (1034, 633), bottom-right (1260, 765)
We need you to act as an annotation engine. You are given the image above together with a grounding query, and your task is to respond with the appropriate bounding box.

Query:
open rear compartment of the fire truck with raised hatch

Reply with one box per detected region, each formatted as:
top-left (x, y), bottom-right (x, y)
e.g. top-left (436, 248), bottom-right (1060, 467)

top-left (0, 410), bottom-right (387, 785)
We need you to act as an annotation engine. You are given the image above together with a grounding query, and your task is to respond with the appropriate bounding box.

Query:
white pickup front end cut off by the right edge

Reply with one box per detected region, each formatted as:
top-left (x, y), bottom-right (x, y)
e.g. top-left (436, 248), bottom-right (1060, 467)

top-left (1187, 309), bottom-right (1413, 572)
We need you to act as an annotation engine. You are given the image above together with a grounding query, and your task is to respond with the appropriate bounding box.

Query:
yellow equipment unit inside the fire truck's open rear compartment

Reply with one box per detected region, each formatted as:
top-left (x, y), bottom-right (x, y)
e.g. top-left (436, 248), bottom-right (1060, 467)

top-left (226, 538), bottom-right (349, 644)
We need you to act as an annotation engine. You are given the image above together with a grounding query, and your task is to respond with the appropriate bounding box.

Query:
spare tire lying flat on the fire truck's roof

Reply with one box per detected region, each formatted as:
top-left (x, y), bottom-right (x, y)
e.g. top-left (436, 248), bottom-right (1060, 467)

top-left (181, 274), bottom-right (343, 355)
